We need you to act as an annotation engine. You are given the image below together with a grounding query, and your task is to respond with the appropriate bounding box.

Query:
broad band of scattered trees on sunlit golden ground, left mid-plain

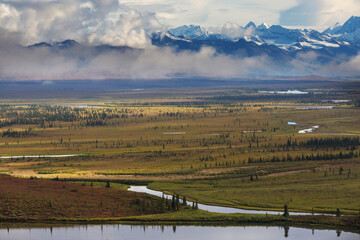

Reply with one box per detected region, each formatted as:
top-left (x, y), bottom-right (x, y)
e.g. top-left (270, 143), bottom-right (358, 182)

top-left (0, 106), bottom-right (197, 128)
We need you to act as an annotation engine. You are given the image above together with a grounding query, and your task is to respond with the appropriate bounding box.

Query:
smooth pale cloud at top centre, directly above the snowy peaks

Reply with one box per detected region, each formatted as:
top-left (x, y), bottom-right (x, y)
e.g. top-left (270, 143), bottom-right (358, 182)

top-left (119, 0), bottom-right (296, 27)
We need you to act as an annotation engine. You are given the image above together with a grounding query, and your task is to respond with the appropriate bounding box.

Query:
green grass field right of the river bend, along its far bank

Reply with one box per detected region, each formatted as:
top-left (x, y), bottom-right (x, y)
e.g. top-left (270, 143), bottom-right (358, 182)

top-left (149, 165), bottom-right (360, 214)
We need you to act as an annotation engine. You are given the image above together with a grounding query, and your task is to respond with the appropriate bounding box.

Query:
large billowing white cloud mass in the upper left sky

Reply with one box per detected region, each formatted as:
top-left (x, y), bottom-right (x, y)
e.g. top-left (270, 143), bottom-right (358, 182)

top-left (0, 0), bottom-right (163, 48)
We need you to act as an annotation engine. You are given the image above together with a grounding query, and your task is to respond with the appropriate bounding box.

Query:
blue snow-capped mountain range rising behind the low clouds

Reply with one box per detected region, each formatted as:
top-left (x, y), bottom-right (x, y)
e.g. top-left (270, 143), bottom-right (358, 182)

top-left (28, 16), bottom-right (360, 64)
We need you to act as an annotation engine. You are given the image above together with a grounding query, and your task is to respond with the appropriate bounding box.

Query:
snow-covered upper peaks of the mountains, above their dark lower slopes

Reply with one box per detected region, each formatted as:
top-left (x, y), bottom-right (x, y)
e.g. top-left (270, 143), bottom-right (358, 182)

top-left (169, 17), bottom-right (360, 51)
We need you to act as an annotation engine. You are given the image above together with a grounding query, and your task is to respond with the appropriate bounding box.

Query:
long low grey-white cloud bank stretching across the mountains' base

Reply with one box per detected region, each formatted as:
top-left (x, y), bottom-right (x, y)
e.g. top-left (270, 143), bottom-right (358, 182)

top-left (0, 40), bottom-right (360, 80)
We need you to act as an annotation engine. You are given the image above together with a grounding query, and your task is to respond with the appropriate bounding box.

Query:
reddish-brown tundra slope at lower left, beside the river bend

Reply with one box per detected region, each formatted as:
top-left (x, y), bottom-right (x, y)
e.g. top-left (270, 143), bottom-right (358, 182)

top-left (0, 176), bottom-right (165, 220)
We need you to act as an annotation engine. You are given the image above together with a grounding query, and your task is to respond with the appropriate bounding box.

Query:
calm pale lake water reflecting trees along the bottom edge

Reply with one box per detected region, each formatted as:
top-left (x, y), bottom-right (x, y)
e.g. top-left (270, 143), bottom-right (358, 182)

top-left (0, 225), bottom-right (359, 240)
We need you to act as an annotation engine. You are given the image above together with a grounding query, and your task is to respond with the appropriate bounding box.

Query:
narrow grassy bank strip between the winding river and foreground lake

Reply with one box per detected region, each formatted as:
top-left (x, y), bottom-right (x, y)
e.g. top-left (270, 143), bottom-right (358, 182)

top-left (0, 207), bottom-right (360, 233)
